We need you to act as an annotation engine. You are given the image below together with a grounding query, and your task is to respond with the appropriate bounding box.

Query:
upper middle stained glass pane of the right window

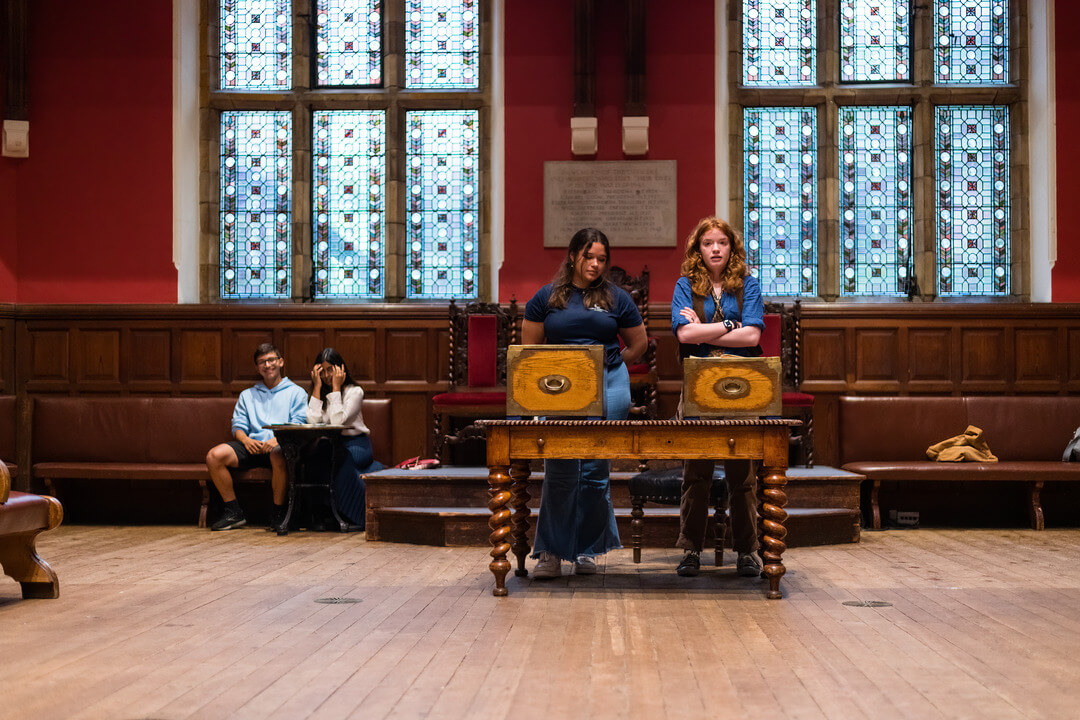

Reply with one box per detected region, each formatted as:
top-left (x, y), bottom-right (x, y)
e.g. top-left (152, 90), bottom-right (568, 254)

top-left (840, 0), bottom-right (912, 82)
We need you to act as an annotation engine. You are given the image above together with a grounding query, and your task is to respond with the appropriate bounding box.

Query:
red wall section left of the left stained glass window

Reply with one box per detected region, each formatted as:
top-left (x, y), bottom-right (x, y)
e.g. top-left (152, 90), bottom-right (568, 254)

top-left (11, 0), bottom-right (176, 302)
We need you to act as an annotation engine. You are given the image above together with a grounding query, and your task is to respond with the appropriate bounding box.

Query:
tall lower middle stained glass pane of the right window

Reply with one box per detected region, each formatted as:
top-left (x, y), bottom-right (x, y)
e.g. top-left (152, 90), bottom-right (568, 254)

top-left (840, 107), bottom-right (913, 296)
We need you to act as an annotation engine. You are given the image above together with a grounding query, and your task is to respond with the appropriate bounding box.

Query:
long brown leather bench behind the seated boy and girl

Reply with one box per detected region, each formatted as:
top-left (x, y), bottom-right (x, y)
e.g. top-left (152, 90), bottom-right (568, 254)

top-left (30, 395), bottom-right (391, 527)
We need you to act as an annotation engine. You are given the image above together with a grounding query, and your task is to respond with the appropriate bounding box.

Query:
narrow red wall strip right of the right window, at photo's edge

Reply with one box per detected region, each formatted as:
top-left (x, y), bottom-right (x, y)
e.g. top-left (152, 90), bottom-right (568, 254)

top-left (1051, 2), bottom-right (1080, 302)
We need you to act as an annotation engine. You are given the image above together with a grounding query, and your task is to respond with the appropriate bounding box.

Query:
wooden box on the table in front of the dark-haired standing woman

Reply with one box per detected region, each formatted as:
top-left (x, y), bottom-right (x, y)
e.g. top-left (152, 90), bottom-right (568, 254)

top-left (507, 345), bottom-right (604, 418)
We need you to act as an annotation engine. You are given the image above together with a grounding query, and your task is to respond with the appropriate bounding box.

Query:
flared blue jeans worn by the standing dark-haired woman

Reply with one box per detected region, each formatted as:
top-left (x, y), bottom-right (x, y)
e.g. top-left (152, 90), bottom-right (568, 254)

top-left (532, 364), bottom-right (630, 560)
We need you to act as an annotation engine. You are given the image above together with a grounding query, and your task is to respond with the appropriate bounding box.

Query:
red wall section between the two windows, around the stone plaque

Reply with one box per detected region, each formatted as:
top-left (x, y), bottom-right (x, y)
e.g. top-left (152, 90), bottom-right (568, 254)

top-left (499, 0), bottom-right (716, 302)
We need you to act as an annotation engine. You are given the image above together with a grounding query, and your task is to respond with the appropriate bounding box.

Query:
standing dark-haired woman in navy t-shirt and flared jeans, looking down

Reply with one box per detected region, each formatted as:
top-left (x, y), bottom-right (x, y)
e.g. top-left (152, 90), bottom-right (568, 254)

top-left (522, 228), bottom-right (648, 580)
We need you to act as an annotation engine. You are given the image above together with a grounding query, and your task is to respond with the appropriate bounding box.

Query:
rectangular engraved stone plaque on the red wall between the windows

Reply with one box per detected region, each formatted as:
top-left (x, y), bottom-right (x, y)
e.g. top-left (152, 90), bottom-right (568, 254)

top-left (543, 160), bottom-right (678, 247)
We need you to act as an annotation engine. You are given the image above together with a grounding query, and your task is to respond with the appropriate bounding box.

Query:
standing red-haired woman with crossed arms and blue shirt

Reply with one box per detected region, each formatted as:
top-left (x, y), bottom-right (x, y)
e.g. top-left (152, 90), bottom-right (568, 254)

top-left (672, 217), bottom-right (765, 576)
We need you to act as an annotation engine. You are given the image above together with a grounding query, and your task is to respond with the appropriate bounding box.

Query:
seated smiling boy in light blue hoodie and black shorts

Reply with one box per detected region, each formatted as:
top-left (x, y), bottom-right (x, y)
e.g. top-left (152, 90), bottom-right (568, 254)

top-left (206, 342), bottom-right (308, 530)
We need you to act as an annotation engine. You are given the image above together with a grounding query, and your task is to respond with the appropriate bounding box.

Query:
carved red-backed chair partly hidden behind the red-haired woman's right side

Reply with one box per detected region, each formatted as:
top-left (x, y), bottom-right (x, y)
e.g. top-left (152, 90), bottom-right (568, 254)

top-left (761, 300), bottom-right (813, 467)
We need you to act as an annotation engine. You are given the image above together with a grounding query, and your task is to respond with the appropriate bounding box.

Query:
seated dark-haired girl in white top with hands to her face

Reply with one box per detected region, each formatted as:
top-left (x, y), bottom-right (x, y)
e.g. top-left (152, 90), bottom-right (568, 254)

top-left (308, 348), bottom-right (374, 529)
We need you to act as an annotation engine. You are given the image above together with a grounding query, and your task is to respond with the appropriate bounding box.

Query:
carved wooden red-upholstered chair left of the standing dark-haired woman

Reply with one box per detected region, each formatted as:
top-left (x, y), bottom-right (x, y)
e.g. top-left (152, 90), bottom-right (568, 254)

top-left (432, 300), bottom-right (517, 464)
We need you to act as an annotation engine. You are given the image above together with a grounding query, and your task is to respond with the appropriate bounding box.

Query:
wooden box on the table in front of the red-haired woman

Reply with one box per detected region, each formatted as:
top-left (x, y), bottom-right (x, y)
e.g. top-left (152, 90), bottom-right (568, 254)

top-left (683, 355), bottom-right (782, 418)
